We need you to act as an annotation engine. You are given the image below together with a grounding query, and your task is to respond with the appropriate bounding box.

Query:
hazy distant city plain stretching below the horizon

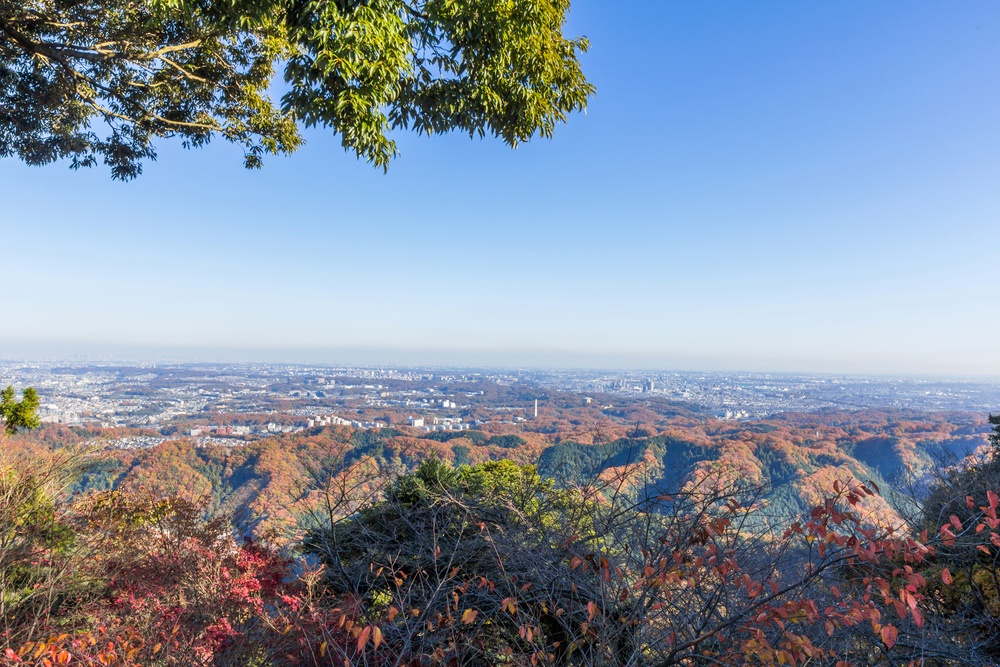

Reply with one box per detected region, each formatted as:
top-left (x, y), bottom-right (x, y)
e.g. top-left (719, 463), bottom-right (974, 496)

top-left (0, 361), bottom-right (1000, 447)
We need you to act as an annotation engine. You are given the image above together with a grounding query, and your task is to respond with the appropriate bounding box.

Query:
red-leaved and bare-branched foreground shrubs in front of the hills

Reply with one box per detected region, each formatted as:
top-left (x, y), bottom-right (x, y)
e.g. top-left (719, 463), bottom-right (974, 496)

top-left (0, 420), bottom-right (1000, 667)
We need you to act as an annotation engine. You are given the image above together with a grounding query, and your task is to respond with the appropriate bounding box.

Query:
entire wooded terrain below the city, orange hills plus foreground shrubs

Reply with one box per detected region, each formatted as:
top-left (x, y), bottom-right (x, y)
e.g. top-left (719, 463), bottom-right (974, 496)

top-left (0, 412), bottom-right (1000, 667)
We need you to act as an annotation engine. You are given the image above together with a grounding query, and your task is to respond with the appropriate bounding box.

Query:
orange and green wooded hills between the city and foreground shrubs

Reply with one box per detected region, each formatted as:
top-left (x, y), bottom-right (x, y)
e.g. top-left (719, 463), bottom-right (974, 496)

top-left (0, 411), bottom-right (988, 536)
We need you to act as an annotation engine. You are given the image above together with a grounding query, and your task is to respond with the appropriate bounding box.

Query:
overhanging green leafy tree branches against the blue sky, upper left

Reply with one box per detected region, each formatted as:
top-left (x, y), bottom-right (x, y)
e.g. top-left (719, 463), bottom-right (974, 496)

top-left (0, 0), bottom-right (594, 180)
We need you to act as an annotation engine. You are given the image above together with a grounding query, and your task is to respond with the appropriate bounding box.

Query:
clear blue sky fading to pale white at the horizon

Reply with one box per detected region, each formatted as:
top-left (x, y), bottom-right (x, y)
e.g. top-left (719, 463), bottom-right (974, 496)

top-left (0, 0), bottom-right (1000, 374)
